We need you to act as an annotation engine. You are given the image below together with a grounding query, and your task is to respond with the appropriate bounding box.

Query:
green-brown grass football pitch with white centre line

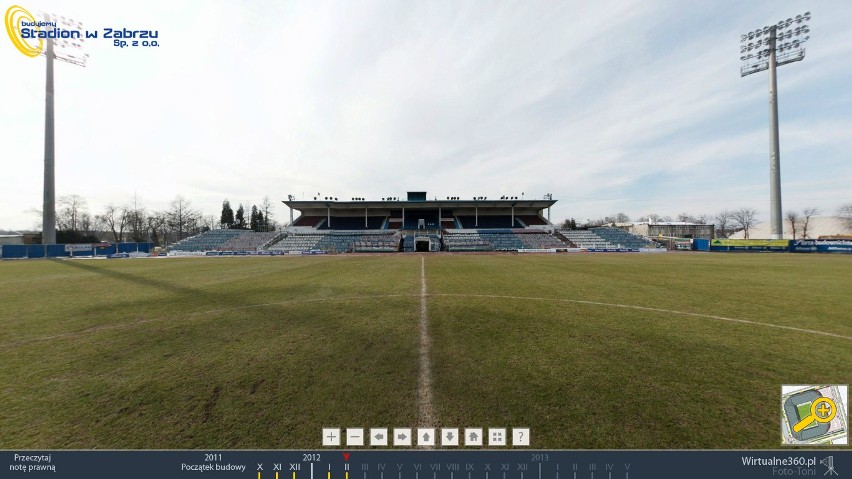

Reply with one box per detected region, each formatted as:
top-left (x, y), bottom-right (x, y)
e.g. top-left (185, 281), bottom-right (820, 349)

top-left (0, 254), bottom-right (852, 449)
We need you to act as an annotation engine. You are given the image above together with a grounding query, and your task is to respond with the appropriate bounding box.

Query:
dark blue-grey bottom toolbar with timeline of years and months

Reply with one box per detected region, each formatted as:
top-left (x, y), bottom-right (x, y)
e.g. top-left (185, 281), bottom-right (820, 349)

top-left (0, 448), bottom-right (852, 479)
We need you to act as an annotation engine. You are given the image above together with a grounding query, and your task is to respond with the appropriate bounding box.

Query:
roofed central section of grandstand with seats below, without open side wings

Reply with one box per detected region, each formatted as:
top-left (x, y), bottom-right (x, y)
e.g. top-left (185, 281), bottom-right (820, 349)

top-left (269, 192), bottom-right (568, 252)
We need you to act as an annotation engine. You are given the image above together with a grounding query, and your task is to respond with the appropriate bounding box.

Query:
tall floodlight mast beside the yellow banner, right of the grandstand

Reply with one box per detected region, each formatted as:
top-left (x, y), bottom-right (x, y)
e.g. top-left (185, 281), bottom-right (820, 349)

top-left (740, 12), bottom-right (811, 239)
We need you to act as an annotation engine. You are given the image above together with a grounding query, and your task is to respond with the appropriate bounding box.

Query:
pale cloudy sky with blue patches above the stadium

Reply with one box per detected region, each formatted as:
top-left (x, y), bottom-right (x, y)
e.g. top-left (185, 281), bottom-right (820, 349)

top-left (0, 0), bottom-right (852, 229)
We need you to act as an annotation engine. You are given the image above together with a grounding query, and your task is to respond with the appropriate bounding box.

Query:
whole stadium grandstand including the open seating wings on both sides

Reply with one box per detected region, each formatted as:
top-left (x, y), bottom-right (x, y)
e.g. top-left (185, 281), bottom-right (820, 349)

top-left (165, 192), bottom-right (657, 254)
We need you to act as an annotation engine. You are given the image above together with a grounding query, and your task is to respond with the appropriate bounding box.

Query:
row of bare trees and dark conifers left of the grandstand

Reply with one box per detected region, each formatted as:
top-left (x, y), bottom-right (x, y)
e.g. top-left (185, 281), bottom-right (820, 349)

top-left (43, 195), bottom-right (276, 245)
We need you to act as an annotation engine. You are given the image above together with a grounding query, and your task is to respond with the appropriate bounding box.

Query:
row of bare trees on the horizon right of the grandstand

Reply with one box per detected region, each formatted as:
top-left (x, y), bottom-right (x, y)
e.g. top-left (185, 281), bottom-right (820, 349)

top-left (559, 204), bottom-right (840, 239)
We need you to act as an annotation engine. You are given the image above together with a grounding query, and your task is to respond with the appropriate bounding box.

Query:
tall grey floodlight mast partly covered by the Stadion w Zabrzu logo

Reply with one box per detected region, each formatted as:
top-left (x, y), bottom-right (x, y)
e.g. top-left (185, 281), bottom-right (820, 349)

top-left (41, 13), bottom-right (89, 244)
